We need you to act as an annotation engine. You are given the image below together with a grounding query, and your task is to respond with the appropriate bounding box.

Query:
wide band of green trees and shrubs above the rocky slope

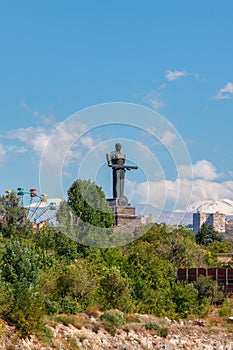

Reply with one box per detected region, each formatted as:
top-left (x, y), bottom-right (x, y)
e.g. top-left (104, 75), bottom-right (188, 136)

top-left (0, 180), bottom-right (233, 336)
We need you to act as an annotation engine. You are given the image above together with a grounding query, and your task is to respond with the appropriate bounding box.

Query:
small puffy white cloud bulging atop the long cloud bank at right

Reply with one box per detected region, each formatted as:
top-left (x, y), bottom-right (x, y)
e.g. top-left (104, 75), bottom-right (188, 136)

top-left (178, 160), bottom-right (219, 180)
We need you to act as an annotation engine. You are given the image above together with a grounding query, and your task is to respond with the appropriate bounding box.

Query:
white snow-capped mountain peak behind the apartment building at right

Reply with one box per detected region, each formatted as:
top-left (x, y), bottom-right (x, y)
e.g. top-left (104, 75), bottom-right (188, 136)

top-left (186, 199), bottom-right (233, 215)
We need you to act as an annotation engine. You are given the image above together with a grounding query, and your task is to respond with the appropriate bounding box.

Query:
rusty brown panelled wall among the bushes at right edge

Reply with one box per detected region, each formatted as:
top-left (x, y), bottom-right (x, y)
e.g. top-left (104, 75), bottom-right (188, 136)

top-left (177, 267), bottom-right (233, 295)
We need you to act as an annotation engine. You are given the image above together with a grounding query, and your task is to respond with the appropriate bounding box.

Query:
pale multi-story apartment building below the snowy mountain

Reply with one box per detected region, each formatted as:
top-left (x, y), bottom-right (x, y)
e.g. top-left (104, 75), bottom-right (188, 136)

top-left (193, 211), bottom-right (226, 233)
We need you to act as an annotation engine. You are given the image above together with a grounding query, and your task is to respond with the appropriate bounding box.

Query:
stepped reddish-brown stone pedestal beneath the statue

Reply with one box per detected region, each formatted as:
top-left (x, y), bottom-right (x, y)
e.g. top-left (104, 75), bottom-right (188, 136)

top-left (107, 198), bottom-right (141, 228)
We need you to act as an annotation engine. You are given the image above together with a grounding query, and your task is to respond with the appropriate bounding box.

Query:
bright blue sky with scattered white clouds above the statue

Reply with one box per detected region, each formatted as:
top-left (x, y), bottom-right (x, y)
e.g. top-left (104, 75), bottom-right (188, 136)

top-left (0, 0), bottom-right (233, 208)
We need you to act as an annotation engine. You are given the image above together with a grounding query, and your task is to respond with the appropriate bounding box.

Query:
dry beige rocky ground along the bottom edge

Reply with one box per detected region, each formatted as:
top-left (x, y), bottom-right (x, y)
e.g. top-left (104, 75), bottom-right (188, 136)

top-left (0, 310), bottom-right (233, 350)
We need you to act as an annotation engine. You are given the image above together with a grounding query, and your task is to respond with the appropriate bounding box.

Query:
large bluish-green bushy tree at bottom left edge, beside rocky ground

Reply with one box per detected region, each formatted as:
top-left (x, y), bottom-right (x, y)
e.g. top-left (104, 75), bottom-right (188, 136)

top-left (1, 240), bottom-right (44, 336)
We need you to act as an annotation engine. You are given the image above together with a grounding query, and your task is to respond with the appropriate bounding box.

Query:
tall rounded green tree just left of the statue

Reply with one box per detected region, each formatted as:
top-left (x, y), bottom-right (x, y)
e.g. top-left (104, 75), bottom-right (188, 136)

top-left (57, 180), bottom-right (114, 247)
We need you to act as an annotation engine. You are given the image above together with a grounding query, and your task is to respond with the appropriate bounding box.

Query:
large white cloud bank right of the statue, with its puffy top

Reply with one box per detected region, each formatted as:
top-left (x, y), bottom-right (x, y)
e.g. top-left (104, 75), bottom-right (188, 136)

top-left (134, 160), bottom-right (230, 210)
